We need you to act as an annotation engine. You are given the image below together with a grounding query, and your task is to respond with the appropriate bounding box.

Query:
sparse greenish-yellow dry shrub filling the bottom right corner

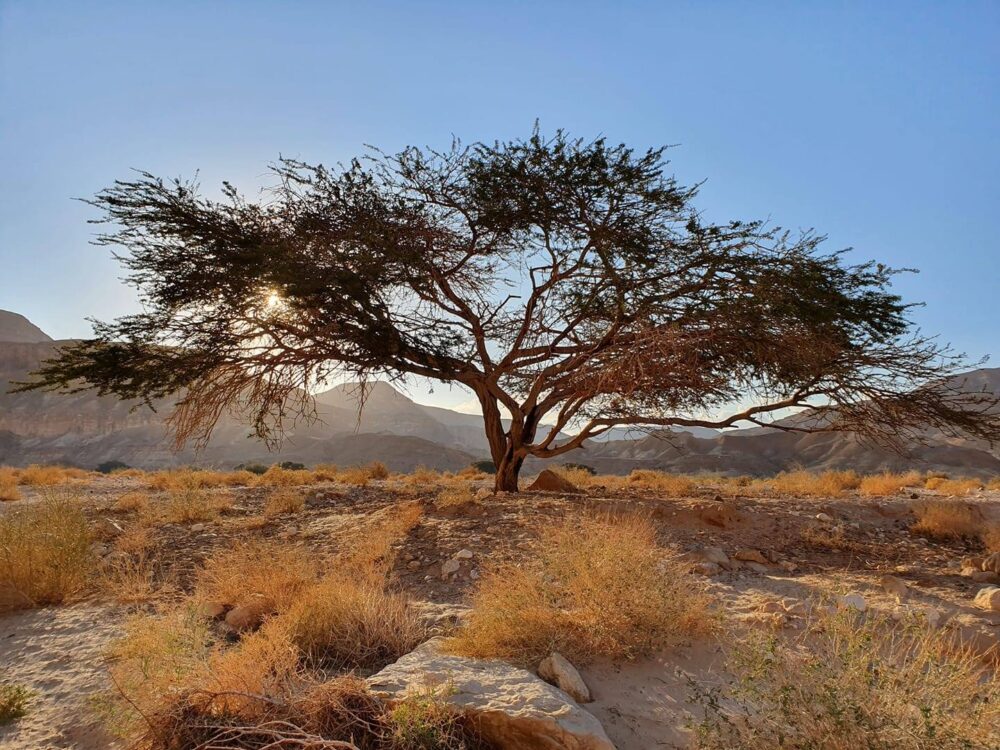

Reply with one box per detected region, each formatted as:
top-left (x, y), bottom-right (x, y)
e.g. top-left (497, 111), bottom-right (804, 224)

top-left (695, 613), bottom-right (1000, 750)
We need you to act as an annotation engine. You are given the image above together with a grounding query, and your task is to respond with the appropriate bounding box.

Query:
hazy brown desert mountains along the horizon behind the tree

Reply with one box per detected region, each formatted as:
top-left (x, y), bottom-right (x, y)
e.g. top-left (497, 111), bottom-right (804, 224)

top-left (0, 310), bottom-right (1000, 475)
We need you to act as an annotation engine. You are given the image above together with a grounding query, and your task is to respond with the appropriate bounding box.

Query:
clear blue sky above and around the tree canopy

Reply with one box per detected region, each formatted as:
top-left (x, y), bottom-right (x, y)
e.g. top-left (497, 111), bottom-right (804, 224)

top-left (0, 0), bottom-right (1000, 412)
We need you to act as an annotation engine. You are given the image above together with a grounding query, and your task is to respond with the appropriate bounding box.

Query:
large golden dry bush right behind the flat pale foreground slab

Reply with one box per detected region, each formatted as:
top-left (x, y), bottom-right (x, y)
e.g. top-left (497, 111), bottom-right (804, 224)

top-left (452, 517), bottom-right (714, 665)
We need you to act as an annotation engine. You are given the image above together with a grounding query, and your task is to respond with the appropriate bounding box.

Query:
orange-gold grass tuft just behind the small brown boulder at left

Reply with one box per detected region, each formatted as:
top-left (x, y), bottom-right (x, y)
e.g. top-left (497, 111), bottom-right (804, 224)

top-left (195, 541), bottom-right (318, 612)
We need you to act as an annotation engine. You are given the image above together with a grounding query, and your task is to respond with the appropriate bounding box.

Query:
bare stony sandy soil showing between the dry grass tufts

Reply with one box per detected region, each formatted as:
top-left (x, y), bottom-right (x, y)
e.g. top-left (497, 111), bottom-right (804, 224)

top-left (0, 478), bottom-right (1000, 750)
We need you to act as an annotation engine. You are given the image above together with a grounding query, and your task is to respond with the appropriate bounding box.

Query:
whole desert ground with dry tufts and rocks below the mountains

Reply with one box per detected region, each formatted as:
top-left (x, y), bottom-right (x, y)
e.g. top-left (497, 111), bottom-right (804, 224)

top-left (0, 465), bottom-right (1000, 750)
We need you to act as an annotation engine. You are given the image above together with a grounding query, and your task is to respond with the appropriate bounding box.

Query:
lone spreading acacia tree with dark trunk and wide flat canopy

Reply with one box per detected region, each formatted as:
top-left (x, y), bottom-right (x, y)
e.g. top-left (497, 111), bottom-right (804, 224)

top-left (26, 129), bottom-right (1000, 491)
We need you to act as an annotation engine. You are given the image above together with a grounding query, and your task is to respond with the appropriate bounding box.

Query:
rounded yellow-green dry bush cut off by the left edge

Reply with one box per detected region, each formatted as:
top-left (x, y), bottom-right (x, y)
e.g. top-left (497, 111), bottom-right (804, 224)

top-left (0, 497), bottom-right (94, 607)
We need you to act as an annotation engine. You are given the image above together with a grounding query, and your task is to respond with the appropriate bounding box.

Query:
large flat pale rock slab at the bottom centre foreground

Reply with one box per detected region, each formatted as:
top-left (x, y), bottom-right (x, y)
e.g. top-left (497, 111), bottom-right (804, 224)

top-left (367, 638), bottom-right (615, 750)
